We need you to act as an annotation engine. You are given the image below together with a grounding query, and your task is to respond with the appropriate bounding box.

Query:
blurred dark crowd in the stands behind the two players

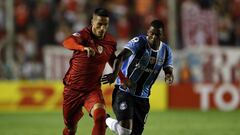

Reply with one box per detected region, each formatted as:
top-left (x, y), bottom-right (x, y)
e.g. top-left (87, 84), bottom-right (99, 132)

top-left (0, 0), bottom-right (240, 79)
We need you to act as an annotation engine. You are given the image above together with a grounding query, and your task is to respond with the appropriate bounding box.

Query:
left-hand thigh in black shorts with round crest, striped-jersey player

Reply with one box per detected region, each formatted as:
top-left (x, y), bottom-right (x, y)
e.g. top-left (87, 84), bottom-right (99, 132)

top-left (112, 87), bottom-right (134, 121)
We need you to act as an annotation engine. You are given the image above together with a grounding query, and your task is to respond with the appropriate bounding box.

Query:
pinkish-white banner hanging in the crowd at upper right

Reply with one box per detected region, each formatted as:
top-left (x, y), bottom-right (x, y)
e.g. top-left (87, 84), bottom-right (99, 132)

top-left (181, 0), bottom-right (217, 47)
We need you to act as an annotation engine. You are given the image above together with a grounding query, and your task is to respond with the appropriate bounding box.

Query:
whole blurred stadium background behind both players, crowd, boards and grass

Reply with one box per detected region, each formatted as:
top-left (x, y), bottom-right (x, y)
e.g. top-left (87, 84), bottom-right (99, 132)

top-left (0, 0), bottom-right (240, 135)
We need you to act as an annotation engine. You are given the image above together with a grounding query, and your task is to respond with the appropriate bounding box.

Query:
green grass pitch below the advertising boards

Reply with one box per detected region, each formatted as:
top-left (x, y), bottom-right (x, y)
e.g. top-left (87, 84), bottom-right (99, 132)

top-left (0, 110), bottom-right (240, 135)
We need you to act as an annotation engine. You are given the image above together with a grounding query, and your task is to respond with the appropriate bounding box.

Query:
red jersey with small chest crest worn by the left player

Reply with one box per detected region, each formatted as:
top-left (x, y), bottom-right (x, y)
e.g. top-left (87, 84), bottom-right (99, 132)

top-left (63, 27), bottom-right (117, 91)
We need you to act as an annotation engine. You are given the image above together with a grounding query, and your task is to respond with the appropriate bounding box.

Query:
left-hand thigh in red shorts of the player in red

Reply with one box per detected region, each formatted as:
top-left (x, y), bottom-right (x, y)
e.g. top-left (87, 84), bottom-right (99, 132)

top-left (63, 87), bottom-right (84, 126)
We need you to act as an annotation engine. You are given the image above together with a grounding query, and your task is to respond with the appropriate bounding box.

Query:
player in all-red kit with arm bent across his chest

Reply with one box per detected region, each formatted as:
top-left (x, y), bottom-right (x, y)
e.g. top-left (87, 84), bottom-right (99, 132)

top-left (63, 8), bottom-right (117, 135)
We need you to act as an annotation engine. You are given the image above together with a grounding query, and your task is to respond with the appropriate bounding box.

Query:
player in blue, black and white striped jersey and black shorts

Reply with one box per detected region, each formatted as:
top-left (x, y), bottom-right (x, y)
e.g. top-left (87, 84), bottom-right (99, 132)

top-left (102, 20), bottom-right (173, 135)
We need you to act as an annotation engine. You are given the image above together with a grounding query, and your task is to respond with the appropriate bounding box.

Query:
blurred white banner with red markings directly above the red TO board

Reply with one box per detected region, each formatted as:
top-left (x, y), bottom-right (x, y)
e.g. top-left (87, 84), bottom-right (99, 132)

top-left (174, 48), bottom-right (240, 85)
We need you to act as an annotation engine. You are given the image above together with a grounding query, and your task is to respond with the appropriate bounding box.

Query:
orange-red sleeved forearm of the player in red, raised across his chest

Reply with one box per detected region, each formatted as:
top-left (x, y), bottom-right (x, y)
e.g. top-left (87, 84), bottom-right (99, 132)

top-left (63, 36), bottom-right (84, 51)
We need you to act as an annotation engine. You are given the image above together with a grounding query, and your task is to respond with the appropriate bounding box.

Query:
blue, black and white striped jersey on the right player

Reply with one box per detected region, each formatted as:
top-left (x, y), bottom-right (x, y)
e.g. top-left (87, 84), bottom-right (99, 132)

top-left (116, 35), bottom-right (173, 98)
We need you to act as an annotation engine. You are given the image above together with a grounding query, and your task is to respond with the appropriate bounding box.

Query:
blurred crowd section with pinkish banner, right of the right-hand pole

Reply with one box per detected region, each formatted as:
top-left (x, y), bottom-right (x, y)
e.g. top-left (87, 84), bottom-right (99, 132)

top-left (177, 0), bottom-right (240, 48)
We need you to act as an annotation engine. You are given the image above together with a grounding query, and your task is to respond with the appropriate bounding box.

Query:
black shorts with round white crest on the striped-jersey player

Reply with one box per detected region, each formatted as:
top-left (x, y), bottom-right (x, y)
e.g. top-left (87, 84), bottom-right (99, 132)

top-left (112, 85), bottom-right (150, 135)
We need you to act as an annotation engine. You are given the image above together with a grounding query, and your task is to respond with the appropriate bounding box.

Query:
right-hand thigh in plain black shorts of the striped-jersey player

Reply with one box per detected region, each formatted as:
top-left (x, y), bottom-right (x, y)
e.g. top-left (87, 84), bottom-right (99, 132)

top-left (132, 98), bottom-right (150, 135)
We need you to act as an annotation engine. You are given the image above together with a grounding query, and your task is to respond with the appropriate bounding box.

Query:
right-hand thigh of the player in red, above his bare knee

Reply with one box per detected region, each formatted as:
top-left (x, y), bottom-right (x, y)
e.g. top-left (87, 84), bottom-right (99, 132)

top-left (84, 89), bottom-right (105, 114)
